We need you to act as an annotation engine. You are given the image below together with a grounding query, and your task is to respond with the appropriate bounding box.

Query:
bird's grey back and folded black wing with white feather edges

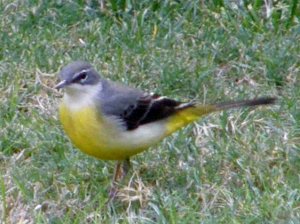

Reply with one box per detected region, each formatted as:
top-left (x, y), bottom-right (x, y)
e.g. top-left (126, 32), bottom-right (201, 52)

top-left (98, 80), bottom-right (194, 130)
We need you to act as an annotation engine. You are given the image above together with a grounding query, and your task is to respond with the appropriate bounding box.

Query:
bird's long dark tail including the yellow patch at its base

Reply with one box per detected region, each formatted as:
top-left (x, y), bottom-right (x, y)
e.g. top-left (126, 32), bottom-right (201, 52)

top-left (167, 97), bottom-right (276, 134)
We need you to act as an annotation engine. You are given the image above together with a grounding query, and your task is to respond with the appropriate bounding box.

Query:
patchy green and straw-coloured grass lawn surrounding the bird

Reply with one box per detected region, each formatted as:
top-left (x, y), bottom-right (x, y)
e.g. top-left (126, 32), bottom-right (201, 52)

top-left (0, 0), bottom-right (300, 223)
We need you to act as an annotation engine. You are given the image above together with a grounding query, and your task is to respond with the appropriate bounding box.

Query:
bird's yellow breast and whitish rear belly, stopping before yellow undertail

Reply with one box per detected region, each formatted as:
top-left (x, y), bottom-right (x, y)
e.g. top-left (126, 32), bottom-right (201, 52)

top-left (60, 103), bottom-right (163, 160)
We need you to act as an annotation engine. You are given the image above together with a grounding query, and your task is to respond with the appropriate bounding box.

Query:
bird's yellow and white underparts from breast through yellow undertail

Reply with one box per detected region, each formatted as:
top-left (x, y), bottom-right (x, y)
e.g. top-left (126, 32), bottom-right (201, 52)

top-left (60, 103), bottom-right (216, 160)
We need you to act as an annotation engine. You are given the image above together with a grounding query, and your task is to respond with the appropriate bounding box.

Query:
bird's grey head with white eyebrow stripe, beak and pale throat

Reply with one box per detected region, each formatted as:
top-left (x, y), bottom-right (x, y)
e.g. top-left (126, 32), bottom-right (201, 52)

top-left (55, 61), bottom-right (100, 95)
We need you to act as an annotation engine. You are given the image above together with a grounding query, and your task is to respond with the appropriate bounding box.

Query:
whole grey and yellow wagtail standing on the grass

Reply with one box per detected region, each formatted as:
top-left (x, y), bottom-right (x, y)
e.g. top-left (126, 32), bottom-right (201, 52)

top-left (55, 61), bottom-right (275, 196)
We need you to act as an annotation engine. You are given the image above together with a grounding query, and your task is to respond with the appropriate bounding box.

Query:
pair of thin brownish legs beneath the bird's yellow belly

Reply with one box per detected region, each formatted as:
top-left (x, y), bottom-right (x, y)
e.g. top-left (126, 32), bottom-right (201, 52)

top-left (109, 159), bottom-right (130, 199)
